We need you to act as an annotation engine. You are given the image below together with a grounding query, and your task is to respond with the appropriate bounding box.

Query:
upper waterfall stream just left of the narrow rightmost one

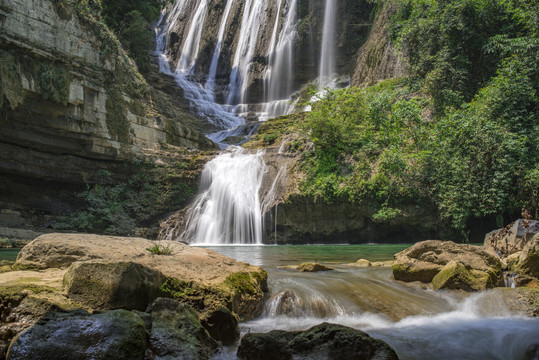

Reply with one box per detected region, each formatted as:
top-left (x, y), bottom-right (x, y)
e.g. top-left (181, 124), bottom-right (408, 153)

top-left (261, 0), bottom-right (297, 120)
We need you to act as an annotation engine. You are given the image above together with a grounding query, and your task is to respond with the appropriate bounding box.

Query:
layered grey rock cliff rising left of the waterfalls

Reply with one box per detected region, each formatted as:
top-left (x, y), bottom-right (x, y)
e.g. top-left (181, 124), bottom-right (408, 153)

top-left (0, 0), bottom-right (214, 232)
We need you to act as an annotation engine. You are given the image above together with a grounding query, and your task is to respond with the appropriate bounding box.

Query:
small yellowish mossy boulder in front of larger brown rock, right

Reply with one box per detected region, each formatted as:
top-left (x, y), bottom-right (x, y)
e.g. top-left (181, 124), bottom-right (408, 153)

top-left (432, 261), bottom-right (493, 291)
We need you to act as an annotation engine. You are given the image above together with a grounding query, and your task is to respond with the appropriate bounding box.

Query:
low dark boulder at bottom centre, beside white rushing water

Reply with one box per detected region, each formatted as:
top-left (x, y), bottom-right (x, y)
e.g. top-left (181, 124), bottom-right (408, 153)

top-left (237, 323), bottom-right (398, 360)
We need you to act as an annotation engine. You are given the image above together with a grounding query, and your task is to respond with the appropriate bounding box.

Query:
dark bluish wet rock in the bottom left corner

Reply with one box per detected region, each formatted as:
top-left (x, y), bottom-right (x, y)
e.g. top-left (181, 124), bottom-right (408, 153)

top-left (7, 310), bottom-right (146, 360)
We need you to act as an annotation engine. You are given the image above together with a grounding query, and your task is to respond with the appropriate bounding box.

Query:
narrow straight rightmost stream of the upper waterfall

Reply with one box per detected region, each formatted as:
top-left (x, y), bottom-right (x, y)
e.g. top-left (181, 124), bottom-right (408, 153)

top-left (318, 0), bottom-right (337, 91)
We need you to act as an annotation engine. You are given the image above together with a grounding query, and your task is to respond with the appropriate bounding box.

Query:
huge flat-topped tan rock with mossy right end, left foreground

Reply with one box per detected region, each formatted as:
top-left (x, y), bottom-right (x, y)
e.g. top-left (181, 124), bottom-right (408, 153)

top-left (15, 234), bottom-right (267, 342)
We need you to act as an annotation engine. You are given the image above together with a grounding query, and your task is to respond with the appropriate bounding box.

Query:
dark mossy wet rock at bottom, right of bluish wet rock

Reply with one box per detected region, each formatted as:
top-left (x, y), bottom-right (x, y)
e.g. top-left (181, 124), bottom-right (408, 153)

top-left (150, 298), bottom-right (218, 360)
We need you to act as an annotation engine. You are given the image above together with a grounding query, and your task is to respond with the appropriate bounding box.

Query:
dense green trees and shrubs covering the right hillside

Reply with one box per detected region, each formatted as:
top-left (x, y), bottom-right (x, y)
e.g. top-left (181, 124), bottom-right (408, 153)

top-left (303, 0), bottom-right (539, 237)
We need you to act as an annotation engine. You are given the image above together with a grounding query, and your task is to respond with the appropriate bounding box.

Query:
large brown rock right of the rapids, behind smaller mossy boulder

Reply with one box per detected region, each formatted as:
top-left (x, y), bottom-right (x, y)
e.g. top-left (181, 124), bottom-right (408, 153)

top-left (393, 240), bottom-right (503, 290)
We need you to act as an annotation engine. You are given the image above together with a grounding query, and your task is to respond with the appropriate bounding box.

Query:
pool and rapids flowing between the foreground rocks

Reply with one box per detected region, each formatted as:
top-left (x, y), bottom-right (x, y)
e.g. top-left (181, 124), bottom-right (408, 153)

top-left (204, 245), bottom-right (539, 360)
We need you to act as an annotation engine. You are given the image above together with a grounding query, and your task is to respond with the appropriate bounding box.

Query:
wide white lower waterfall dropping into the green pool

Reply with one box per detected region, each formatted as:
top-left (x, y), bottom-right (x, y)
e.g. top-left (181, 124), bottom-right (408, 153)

top-left (182, 146), bottom-right (266, 244)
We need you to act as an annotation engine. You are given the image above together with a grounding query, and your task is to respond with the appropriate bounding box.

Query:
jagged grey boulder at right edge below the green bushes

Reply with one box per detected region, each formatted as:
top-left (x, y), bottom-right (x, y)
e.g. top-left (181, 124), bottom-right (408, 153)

top-left (483, 219), bottom-right (539, 256)
